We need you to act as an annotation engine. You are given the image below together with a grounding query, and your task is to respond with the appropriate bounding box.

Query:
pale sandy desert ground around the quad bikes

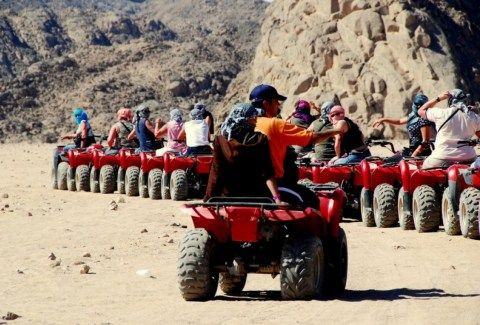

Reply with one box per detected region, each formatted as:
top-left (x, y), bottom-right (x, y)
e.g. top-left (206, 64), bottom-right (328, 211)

top-left (0, 144), bottom-right (480, 324)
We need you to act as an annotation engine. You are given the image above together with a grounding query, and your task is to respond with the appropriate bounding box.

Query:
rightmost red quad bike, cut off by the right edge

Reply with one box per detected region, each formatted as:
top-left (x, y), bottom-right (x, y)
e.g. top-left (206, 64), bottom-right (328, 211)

top-left (442, 140), bottom-right (480, 239)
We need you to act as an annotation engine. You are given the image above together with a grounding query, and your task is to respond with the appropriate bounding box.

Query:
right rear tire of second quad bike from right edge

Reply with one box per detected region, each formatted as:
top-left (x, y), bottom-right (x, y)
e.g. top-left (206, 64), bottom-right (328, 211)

top-left (412, 185), bottom-right (440, 232)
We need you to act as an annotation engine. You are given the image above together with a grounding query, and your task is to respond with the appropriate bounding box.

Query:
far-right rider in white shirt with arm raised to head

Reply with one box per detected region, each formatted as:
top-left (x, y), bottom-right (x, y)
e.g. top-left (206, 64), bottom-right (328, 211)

top-left (418, 89), bottom-right (480, 168)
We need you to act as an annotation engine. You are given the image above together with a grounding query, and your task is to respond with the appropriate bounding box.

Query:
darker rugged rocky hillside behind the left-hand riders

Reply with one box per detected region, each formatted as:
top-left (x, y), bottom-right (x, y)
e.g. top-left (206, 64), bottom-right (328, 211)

top-left (0, 0), bottom-right (268, 142)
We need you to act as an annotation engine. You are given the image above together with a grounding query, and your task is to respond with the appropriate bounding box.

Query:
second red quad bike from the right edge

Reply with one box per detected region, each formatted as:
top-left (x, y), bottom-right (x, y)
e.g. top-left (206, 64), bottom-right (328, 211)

top-left (398, 157), bottom-right (448, 232)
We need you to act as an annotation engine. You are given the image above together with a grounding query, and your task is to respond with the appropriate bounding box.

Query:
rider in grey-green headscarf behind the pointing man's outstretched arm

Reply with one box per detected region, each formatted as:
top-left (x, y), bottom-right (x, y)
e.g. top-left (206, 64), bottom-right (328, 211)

top-left (308, 101), bottom-right (335, 162)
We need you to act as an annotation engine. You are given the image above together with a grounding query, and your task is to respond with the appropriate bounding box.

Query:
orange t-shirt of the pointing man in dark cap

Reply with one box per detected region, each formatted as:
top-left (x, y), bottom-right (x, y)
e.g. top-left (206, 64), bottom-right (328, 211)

top-left (255, 117), bottom-right (313, 178)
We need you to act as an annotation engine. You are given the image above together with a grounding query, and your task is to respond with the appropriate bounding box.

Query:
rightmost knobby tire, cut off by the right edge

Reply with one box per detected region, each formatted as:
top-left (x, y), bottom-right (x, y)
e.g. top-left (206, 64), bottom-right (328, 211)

top-left (459, 187), bottom-right (480, 239)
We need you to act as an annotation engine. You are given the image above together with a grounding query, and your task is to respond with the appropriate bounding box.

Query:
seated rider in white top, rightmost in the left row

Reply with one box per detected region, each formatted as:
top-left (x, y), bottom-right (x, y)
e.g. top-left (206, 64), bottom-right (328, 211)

top-left (178, 108), bottom-right (212, 155)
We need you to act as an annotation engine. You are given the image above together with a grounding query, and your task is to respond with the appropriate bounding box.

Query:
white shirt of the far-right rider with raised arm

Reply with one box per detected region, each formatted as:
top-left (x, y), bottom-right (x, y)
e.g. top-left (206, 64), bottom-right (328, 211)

top-left (426, 106), bottom-right (480, 160)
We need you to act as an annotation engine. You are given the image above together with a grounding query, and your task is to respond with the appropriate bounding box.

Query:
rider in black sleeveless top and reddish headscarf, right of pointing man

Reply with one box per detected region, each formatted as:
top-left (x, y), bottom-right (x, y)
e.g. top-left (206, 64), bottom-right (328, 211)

top-left (328, 105), bottom-right (371, 165)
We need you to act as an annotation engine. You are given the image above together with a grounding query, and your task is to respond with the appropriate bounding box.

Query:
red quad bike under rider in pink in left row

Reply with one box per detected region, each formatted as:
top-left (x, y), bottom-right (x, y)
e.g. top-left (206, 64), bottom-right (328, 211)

top-left (138, 152), bottom-right (170, 200)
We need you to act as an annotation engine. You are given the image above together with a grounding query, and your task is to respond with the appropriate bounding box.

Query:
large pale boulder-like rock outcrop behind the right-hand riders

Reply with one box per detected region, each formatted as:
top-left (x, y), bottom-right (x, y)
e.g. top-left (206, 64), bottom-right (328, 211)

top-left (219, 0), bottom-right (480, 136)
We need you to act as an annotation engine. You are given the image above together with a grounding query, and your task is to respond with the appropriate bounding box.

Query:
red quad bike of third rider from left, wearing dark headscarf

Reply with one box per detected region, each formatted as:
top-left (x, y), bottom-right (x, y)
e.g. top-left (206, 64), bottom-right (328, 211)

top-left (117, 149), bottom-right (141, 196)
